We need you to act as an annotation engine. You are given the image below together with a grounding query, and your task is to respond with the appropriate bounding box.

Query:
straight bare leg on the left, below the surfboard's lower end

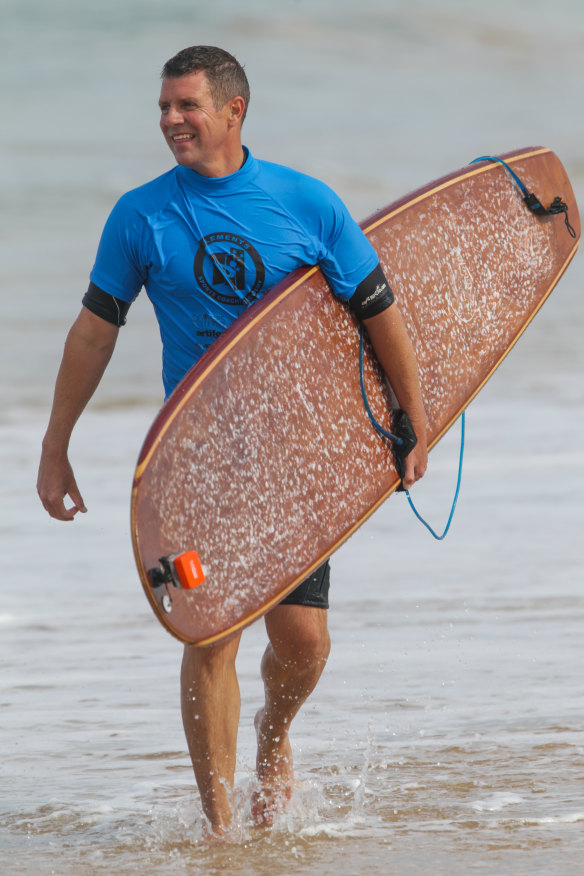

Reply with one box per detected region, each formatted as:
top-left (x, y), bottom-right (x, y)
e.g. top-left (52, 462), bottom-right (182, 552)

top-left (181, 635), bottom-right (241, 836)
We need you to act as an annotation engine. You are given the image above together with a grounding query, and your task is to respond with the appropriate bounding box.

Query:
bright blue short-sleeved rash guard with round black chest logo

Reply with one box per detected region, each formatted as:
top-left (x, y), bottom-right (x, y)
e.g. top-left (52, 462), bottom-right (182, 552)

top-left (91, 147), bottom-right (379, 395)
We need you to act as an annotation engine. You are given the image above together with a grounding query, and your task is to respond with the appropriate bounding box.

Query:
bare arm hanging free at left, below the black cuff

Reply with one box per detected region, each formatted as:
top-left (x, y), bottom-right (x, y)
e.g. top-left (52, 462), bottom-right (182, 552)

top-left (37, 307), bottom-right (119, 520)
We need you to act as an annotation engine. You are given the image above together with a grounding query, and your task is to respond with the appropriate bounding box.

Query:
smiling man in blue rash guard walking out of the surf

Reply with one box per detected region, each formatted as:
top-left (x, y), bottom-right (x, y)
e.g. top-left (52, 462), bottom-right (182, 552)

top-left (38, 46), bottom-right (427, 836)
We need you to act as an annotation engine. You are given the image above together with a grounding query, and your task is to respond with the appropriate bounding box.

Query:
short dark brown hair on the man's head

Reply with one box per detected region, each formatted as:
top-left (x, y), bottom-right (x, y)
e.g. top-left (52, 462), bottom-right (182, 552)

top-left (160, 46), bottom-right (250, 122)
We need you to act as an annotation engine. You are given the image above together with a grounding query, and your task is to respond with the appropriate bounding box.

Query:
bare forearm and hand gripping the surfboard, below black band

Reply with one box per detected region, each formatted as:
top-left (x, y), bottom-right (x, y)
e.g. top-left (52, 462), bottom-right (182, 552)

top-left (363, 302), bottom-right (428, 490)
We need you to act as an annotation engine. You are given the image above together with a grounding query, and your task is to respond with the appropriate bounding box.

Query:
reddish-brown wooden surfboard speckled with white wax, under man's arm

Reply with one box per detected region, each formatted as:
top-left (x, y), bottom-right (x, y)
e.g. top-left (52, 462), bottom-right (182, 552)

top-left (131, 147), bottom-right (580, 645)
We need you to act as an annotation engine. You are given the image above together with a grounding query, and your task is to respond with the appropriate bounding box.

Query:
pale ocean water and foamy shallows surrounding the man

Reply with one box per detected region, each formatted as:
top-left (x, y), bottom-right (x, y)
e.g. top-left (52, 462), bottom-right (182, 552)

top-left (0, 0), bottom-right (584, 876)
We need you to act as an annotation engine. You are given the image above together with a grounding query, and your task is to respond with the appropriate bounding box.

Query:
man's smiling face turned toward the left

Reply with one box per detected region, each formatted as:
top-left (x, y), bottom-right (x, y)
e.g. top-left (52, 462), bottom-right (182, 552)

top-left (159, 71), bottom-right (237, 176)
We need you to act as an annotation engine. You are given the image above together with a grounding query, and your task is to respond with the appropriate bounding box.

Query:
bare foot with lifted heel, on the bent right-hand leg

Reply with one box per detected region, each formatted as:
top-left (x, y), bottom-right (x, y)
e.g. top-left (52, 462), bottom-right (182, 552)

top-left (251, 709), bottom-right (294, 826)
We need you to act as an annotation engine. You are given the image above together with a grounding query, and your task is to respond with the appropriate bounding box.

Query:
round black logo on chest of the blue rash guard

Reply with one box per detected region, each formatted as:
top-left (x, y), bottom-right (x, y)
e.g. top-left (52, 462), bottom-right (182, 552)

top-left (194, 231), bottom-right (266, 307)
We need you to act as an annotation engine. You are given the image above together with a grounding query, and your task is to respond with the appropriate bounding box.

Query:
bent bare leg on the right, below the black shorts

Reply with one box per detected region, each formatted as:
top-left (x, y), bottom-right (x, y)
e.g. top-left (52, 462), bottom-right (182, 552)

top-left (252, 605), bottom-right (330, 824)
